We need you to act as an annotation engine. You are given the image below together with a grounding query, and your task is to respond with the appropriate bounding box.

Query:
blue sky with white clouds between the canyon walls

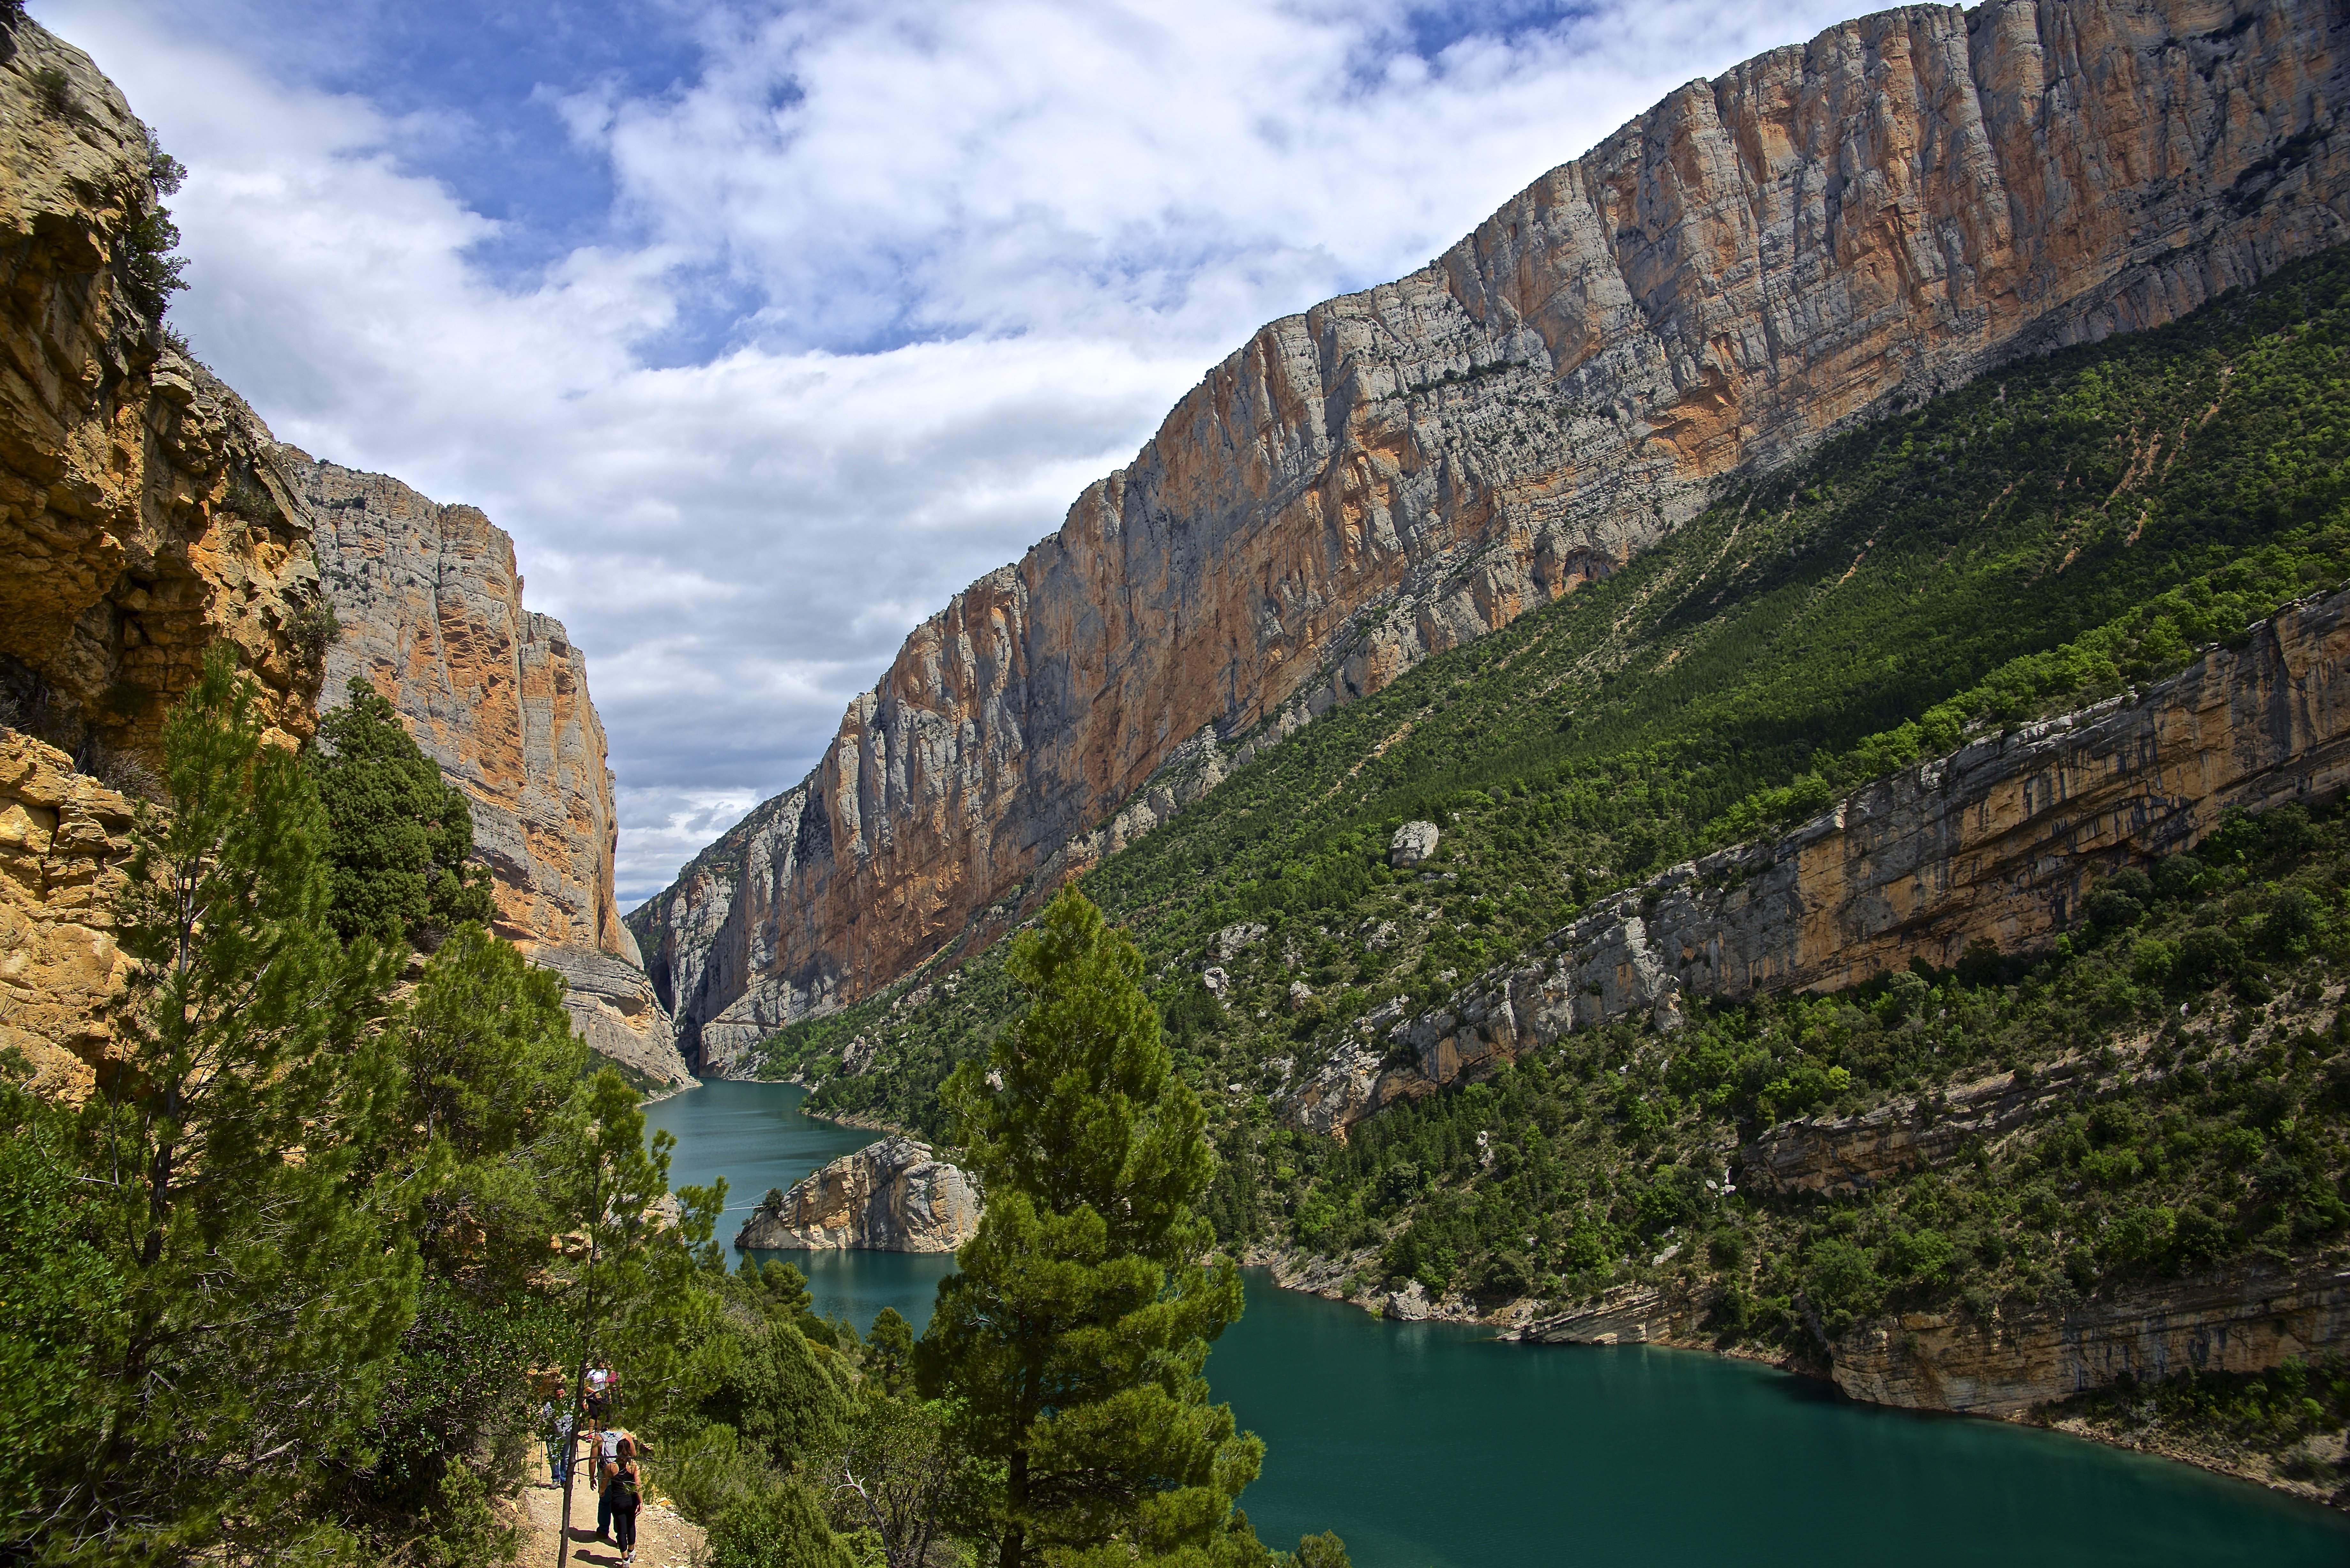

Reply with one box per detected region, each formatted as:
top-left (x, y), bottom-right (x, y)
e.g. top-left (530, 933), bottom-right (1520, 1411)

top-left (28, 0), bottom-right (1866, 908)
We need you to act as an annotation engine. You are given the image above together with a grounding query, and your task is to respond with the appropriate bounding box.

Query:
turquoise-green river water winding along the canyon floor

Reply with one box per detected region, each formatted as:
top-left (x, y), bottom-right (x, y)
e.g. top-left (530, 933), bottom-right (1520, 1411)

top-left (646, 1084), bottom-right (2350, 1568)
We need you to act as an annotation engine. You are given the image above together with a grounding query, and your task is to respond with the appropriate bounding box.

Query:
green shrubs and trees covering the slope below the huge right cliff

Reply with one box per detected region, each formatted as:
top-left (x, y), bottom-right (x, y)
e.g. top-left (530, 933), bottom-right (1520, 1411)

top-left (766, 252), bottom-right (2350, 1495)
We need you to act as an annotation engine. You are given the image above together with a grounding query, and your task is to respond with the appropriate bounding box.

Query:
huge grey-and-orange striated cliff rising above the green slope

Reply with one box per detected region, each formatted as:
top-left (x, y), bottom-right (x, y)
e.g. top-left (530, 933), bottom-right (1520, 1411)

top-left (630, 0), bottom-right (2350, 1063)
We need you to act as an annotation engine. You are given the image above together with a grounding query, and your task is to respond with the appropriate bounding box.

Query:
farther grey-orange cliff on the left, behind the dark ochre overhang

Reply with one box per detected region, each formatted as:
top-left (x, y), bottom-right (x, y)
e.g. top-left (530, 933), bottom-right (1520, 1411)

top-left (301, 461), bottom-right (688, 1084)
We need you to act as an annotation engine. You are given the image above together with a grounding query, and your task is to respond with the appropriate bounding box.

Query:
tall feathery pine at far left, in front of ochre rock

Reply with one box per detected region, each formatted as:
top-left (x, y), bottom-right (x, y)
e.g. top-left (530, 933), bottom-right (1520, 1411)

top-left (42, 649), bottom-right (416, 1561)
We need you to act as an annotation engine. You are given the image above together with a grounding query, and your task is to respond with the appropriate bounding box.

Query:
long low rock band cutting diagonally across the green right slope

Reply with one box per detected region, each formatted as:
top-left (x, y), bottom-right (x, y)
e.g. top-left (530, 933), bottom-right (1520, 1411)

top-left (1283, 592), bottom-right (2350, 1133)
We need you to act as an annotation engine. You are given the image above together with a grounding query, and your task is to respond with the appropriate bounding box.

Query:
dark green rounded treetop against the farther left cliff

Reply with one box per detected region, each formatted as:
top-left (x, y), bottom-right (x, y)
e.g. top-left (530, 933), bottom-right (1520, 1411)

top-left (310, 677), bottom-right (496, 947)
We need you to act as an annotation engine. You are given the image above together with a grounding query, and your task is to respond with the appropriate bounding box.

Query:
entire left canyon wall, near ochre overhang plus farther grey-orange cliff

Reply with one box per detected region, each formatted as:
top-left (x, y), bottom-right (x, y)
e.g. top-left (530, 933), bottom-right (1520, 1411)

top-left (0, 21), bottom-right (686, 1093)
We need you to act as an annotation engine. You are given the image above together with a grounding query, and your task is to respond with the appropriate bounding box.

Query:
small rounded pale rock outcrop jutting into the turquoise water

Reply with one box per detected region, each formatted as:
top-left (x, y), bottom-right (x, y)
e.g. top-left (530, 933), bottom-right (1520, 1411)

top-left (736, 1138), bottom-right (980, 1253)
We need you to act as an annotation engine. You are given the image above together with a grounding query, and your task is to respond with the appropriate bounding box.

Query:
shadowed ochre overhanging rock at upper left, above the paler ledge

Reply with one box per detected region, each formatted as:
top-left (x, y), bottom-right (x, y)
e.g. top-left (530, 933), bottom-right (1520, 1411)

top-left (0, 21), bottom-right (334, 776)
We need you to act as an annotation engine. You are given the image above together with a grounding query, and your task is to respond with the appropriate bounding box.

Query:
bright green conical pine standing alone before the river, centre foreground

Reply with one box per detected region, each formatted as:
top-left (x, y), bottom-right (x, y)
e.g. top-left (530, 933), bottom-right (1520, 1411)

top-left (916, 889), bottom-right (1316, 1568)
